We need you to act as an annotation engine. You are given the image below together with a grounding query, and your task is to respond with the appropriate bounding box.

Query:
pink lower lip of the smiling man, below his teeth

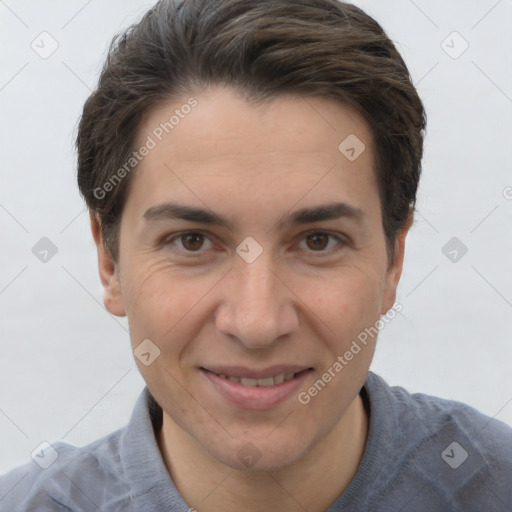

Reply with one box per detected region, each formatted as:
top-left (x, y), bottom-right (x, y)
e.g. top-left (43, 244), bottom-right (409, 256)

top-left (200, 369), bottom-right (311, 411)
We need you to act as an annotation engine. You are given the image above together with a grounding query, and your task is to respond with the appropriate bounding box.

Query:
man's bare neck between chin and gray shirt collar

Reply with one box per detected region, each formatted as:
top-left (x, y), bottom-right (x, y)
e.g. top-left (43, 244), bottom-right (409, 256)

top-left (158, 395), bottom-right (368, 512)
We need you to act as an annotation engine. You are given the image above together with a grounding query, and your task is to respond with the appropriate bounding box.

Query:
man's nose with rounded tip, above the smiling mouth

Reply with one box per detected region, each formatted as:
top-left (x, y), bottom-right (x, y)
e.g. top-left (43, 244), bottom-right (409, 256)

top-left (216, 251), bottom-right (299, 349)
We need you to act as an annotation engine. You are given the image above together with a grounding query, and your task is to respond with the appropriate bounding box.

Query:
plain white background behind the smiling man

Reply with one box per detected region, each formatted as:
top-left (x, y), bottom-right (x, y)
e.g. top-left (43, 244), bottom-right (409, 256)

top-left (0, 0), bottom-right (512, 473)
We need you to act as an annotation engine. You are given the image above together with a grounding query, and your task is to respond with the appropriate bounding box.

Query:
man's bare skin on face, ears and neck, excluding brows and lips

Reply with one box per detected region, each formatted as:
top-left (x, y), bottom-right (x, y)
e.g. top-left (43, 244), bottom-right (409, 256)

top-left (91, 87), bottom-right (412, 512)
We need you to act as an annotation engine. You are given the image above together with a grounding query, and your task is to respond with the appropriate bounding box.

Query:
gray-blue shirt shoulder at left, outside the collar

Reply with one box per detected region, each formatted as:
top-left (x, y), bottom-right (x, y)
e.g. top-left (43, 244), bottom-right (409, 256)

top-left (0, 429), bottom-right (126, 512)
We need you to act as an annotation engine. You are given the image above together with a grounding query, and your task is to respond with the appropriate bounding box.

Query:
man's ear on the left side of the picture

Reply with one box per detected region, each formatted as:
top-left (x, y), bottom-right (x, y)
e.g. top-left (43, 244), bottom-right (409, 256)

top-left (89, 212), bottom-right (126, 316)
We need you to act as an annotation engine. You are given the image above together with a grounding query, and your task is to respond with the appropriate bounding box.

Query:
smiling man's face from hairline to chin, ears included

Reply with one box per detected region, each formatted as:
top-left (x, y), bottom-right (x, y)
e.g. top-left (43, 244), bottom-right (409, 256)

top-left (95, 88), bottom-right (405, 470)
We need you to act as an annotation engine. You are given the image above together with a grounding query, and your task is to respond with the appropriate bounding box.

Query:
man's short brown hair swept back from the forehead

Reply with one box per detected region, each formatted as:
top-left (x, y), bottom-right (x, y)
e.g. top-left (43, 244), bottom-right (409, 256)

top-left (76, 0), bottom-right (426, 261)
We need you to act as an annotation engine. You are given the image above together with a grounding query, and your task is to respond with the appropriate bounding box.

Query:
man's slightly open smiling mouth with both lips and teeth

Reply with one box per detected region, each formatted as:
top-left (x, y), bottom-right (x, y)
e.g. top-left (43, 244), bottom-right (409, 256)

top-left (199, 366), bottom-right (313, 410)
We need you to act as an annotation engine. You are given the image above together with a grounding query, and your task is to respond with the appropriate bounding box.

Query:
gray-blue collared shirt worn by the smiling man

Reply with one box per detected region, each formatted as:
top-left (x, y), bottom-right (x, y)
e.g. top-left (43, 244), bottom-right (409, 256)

top-left (0, 372), bottom-right (512, 512)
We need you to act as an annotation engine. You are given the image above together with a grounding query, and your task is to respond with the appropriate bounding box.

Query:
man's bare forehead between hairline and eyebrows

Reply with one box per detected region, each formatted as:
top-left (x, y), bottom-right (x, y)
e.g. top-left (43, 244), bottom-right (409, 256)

top-left (130, 88), bottom-right (378, 227)
